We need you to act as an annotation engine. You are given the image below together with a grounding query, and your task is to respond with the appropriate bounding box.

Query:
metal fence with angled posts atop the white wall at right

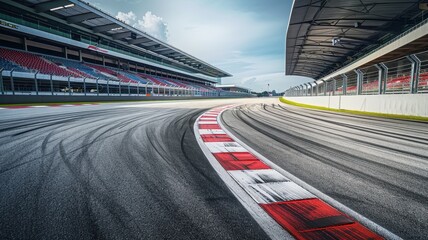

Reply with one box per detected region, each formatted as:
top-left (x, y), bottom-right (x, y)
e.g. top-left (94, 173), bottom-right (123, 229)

top-left (284, 51), bottom-right (428, 96)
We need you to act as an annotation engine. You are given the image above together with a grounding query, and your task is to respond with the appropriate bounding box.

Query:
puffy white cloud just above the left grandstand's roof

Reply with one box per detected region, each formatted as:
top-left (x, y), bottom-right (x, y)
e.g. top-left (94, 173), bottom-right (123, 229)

top-left (116, 11), bottom-right (168, 42)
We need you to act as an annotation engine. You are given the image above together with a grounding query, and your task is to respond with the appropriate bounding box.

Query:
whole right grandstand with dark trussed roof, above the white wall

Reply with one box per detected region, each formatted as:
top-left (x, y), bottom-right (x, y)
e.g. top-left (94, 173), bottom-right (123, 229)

top-left (285, 0), bottom-right (428, 96)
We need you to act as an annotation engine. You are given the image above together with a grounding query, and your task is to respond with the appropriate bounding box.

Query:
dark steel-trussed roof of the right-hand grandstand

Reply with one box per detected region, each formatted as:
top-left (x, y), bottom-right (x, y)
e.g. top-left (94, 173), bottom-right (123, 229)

top-left (285, 0), bottom-right (423, 79)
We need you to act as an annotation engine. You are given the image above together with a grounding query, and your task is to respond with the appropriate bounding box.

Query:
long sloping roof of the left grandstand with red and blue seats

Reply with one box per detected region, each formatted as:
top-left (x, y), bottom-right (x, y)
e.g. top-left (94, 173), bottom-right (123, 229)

top-left (16, 0), bottom-right (231, 77)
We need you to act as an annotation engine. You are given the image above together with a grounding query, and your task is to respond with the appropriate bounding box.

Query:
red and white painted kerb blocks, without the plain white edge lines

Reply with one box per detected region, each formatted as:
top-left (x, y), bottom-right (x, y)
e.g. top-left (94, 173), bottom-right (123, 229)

top-left (197, 106), bottom-right (383, 240)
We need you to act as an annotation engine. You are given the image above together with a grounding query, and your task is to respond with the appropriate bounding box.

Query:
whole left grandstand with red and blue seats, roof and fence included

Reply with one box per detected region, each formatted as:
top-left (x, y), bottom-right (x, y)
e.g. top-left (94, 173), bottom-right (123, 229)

top-left (0, 0), bottom-right (250, 97)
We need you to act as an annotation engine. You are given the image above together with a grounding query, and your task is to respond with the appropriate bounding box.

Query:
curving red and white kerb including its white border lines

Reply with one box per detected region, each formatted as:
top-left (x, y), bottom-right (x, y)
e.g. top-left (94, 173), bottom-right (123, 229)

top-left (194, 105), bottom-right (400, 240)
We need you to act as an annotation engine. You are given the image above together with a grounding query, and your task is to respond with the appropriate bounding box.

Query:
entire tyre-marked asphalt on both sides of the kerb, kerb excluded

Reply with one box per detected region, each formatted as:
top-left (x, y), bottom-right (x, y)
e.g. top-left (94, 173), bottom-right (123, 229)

top-left (0, 99), bottom-right (428, 239)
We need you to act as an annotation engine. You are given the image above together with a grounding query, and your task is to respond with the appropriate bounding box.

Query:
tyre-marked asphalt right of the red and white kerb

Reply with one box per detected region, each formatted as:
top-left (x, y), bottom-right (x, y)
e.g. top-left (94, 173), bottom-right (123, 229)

top-left (222, 100), bottom-right (428, 239)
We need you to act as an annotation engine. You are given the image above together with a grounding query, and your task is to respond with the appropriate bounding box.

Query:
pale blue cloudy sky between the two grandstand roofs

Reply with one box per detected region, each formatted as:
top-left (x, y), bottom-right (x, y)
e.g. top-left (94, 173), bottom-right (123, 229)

top-left (87, 0), bottom-right (312, 92)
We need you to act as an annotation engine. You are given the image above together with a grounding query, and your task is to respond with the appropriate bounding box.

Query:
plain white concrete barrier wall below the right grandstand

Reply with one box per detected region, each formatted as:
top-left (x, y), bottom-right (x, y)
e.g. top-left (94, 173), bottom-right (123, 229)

top-left (285, 94), bottom-right (428, 117)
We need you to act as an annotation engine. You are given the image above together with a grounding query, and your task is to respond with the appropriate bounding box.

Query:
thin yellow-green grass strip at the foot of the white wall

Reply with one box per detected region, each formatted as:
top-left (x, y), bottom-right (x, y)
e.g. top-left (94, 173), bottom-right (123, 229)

top-left (279, 97), bottom-right (428, 122)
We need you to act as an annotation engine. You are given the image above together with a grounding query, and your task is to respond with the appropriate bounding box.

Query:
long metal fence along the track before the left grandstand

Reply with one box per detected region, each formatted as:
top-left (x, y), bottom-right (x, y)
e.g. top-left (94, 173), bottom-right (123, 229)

top-left (0, 69), bottom-right (251, 97)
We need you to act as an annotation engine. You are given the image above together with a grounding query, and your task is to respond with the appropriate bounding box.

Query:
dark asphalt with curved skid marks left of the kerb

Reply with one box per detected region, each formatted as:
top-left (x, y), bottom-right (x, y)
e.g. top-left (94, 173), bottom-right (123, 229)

top-left (0, 100), bottom-right (267, 239)
